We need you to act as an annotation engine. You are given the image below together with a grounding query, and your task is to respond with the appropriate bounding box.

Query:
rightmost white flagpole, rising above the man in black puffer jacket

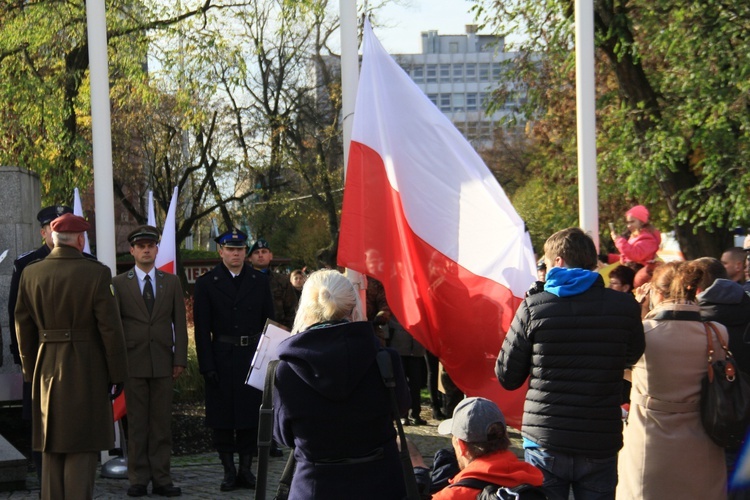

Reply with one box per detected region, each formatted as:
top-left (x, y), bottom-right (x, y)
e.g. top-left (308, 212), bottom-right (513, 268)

top-left (575, 0), bottom-right (599, 250)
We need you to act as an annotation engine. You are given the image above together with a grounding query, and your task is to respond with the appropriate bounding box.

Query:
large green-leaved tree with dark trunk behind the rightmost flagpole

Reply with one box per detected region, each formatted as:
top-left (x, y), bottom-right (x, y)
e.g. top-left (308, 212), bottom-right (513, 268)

top-left (474, 0), bottom-right (750, 258)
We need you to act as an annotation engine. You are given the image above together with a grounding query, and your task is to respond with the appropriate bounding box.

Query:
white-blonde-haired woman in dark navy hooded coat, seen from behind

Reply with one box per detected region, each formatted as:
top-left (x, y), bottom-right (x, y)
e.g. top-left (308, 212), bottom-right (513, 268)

top-left (273, 270), bottom-right (410, 500)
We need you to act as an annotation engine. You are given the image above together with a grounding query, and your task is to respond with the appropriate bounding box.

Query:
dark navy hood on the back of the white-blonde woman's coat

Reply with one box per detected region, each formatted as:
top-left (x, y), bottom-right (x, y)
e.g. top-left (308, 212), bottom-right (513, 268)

top-left (277, 321), bottom-right (379, 401)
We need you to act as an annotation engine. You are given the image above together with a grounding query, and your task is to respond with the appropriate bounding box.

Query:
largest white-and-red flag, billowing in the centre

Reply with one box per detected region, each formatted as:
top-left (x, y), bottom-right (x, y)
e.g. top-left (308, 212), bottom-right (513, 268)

top-left (338, 21), bottom-right (536, 426)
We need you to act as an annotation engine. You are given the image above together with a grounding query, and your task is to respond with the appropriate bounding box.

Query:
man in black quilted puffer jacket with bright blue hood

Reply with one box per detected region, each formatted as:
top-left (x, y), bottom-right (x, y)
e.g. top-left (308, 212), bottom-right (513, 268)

top-left (495, 228), bottom-right (645, 500)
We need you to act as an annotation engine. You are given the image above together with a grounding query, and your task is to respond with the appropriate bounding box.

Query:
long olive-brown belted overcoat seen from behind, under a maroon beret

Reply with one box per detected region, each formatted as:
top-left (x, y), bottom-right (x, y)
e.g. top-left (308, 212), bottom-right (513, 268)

top-left (15, 246), bottom-right (127, 453)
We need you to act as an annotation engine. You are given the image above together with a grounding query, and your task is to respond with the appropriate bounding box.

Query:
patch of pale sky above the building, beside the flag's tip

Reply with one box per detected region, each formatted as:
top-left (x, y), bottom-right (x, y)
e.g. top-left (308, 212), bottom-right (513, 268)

top-left (368, 0), bottom-right (475, 54)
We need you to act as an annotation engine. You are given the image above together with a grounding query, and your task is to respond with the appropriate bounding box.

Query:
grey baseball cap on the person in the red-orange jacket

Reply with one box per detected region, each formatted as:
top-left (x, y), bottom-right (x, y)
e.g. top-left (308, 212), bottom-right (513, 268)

top-left (438, 397), bottom-right (505, 443)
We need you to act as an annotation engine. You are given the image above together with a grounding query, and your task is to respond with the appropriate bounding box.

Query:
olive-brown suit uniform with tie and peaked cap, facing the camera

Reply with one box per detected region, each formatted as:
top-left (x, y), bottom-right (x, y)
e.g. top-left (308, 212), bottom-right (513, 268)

top-left (112, 226), bottom-right (187, 496)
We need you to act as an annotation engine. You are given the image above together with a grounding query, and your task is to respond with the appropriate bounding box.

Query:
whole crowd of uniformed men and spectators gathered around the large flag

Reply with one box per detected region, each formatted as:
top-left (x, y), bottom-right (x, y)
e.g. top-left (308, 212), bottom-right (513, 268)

top-left (9, 201), bottom-right (750, 500)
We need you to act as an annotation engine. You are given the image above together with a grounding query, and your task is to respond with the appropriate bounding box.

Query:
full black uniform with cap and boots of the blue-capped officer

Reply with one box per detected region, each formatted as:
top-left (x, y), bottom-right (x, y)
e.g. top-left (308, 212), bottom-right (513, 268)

top-left (193, 229), bottom-right (274, 491)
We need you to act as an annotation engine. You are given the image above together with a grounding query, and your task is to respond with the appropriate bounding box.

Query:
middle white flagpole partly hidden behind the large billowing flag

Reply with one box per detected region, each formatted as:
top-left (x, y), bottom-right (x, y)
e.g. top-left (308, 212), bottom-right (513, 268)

top-left (339, 0), bottom-right (367, 313)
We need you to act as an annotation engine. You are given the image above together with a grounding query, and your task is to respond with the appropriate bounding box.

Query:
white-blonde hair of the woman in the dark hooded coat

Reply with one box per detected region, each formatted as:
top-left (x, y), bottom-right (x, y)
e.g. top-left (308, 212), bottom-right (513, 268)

top-left (292, 269), bottom-right (364, 335)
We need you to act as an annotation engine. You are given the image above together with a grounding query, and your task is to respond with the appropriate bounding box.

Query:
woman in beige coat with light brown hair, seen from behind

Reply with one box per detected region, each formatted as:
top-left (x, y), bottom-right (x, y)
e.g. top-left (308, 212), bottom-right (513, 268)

top-left (617, 262), bottom-right (727, 500)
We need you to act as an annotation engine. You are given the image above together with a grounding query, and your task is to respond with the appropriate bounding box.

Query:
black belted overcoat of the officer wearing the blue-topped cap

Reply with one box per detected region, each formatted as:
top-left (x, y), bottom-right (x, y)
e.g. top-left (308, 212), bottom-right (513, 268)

top-left (193, 264), bottom-right (274, 429)
